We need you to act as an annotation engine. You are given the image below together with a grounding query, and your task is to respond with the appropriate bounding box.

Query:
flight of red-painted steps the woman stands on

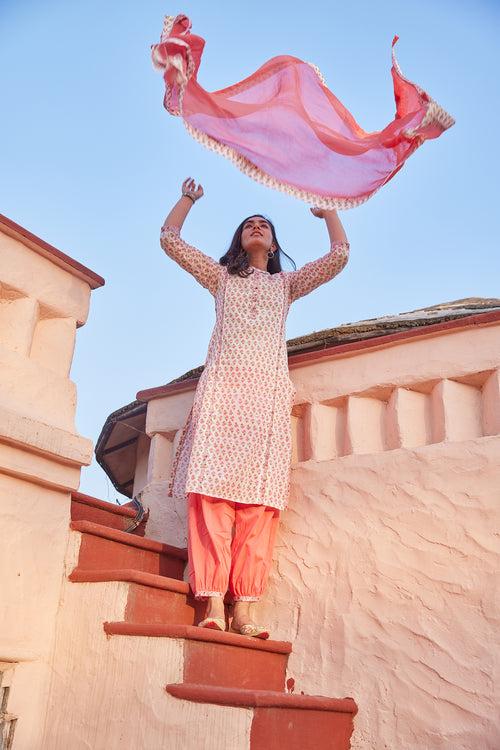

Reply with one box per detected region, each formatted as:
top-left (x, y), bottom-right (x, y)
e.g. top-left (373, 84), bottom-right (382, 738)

top-left (69, 500), bottom-right (357, 750)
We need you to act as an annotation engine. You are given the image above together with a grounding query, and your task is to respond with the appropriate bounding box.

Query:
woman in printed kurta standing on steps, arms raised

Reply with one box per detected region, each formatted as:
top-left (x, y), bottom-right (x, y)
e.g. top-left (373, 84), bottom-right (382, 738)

top-left (161, 178), bottom-right (349, 638)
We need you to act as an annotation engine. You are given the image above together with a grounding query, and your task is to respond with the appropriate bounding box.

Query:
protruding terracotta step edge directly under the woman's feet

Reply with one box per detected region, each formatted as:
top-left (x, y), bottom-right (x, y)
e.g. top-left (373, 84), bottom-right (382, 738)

top-left (104, 622), bottom-right (292, 654)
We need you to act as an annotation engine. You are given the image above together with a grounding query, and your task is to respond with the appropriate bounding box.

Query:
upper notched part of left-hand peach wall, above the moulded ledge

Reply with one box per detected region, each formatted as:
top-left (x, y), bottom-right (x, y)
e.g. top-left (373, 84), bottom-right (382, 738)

top-left (0, 231), bottom-right (90, 432)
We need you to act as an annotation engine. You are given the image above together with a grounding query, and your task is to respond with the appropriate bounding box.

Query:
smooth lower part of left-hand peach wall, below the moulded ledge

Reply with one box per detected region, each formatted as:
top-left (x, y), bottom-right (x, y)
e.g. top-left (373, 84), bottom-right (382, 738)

top-left (0, 476), bottom-right (73, 749)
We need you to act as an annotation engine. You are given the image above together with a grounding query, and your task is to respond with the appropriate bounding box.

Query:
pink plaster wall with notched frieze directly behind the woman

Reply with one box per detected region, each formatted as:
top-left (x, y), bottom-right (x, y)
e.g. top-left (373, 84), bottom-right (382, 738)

top-left (142, 323), bottom-right (500, 750)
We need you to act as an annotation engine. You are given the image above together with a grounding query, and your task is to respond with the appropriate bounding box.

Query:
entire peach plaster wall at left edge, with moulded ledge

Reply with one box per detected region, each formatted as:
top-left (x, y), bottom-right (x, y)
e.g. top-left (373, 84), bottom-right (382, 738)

top-left (0, 223), bottom-right (92, 750)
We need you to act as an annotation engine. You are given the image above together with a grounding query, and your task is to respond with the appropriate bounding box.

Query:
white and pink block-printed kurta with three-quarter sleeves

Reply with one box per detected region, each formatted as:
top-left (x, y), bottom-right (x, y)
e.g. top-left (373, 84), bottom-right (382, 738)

top-left (160, 227), bottom-right (349, 510)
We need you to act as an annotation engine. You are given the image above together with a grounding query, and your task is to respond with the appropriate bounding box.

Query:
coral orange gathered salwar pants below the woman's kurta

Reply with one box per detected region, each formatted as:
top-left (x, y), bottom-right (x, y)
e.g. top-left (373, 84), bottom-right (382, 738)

top-left (188, 492), bottom-right (279, 602)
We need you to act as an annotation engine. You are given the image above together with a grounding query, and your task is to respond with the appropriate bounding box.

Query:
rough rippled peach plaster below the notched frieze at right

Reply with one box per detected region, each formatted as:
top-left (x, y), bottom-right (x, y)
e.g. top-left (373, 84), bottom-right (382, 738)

top-left (264, 436), bottom-right (500, 750)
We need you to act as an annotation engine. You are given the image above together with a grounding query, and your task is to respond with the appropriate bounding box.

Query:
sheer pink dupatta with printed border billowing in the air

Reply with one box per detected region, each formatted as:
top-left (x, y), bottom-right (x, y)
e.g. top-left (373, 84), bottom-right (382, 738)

top-left (152, 15), bottom-right (455, 209)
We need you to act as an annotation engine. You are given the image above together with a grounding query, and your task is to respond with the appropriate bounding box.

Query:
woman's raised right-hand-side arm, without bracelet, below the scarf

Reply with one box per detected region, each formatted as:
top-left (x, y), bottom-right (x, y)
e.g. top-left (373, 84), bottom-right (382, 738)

top-left (286, 208), bottom-right (350, 302)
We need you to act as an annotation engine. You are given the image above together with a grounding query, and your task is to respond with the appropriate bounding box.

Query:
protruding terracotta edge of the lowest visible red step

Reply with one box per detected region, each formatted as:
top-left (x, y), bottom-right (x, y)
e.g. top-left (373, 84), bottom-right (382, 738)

top-left (165, 682), bottom-right (358, 716)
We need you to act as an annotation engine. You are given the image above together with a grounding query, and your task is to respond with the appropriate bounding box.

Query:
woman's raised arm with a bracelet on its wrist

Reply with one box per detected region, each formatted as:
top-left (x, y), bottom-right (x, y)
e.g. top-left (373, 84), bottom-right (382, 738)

top-left (160, 177), bottom-right (223, 296)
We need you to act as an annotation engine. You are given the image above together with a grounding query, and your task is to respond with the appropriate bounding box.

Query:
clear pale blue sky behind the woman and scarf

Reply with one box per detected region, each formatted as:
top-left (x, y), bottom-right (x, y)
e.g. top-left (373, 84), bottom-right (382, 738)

top-left (0, 0), bottom-right (500, 500)
